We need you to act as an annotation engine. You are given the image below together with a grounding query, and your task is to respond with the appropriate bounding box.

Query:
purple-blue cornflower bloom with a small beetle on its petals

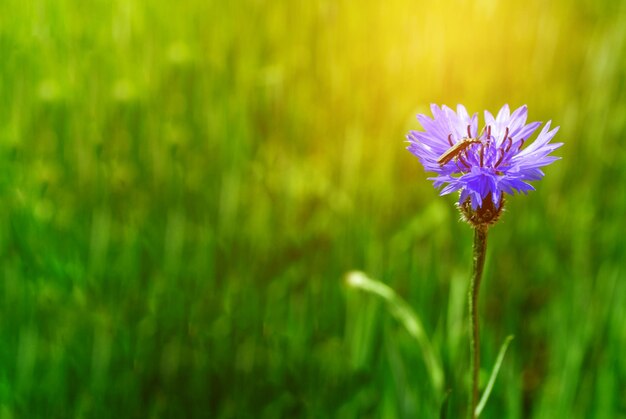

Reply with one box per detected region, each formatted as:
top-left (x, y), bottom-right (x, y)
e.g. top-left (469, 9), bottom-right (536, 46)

top-left (407, 105), bottom-right (563, 211)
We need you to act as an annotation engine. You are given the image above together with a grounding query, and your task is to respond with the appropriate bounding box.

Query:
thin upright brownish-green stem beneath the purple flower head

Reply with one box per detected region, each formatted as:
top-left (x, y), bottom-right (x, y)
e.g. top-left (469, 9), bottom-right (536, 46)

top-left (468, 224), bottom-right (488, 419)
